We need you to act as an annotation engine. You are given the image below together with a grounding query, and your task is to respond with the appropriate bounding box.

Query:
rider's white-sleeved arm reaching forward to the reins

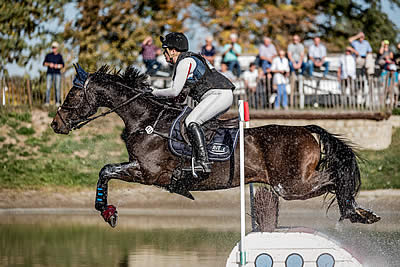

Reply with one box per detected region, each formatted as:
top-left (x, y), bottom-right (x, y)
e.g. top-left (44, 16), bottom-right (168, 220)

top-left (152, 57), bottom-right (197, 97)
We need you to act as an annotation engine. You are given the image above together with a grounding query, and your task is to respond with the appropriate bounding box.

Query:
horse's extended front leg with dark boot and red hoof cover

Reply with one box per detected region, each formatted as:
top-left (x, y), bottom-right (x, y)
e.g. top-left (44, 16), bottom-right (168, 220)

top-left (95, 161), bottom-right (142, 227)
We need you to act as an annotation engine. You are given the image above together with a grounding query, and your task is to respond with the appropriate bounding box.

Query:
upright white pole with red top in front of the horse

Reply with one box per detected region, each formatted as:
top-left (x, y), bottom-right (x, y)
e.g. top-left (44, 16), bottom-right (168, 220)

top-left (239, 100), bottom-right (249, 266)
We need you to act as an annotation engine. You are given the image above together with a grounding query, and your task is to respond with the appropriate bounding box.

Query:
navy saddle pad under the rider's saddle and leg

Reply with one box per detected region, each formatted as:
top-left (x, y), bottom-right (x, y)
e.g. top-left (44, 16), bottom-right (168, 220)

top-left (168, 107), bottom-right (239, 161)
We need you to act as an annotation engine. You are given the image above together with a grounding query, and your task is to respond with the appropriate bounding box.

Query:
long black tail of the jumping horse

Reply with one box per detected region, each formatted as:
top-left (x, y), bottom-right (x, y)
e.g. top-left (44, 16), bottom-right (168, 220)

top-left (304, 125), bottom-right (361, 219)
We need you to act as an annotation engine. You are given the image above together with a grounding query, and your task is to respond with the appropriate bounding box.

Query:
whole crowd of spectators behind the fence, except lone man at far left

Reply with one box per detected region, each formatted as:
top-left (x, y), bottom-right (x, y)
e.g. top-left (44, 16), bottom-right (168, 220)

top-left (137, 32), bottom-right (400, 109)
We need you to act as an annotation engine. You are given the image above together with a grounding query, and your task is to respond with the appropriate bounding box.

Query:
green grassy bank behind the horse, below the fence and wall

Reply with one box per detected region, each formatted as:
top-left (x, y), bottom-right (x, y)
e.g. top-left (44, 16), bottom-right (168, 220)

top-left (0, 109), bottom-right (400, 190)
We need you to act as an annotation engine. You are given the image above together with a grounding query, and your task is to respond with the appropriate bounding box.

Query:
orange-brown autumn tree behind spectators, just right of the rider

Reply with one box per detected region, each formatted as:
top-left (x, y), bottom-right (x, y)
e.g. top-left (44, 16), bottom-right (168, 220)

top-left (195, 0), bottom-right (317, 52)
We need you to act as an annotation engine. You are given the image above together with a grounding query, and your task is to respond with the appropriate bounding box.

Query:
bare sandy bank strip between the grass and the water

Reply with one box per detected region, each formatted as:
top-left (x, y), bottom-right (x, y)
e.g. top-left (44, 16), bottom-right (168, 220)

top-left (0, 186), bottom-right (400, 232)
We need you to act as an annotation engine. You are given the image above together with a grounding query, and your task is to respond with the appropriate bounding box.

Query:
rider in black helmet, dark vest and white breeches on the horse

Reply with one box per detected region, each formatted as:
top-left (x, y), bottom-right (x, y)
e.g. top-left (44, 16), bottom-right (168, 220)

top-left (152, 32), bottom-right (235, 173)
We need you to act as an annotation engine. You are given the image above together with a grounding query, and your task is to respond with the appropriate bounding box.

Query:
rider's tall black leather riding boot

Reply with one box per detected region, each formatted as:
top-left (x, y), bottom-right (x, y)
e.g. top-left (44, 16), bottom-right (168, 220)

top-left (187, 122), bottom-right (211, 173)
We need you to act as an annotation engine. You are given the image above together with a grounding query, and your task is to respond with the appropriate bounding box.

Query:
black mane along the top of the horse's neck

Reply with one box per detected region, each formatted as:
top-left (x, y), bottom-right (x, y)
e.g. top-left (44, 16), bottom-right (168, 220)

top-left (92, 65), bottom-right (150, 93)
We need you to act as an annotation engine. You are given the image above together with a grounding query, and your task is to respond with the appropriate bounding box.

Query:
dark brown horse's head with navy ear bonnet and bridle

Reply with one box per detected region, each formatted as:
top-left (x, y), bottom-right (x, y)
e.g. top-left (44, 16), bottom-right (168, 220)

top-left (51, 64), bottom-right (98, 134)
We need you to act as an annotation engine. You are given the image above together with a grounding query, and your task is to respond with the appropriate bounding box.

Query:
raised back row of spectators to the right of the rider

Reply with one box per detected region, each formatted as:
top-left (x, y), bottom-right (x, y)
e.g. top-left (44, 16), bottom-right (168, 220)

top-left (201, 32), bottom-right (400, 78)
